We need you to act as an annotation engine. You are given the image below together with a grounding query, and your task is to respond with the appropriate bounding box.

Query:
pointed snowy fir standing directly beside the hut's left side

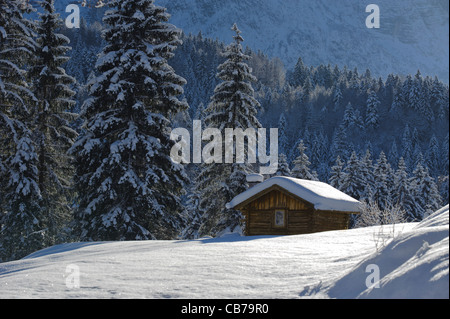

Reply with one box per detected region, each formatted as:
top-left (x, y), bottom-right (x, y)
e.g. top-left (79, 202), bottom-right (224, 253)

top-left (196, 24), bottom-right (261, 236)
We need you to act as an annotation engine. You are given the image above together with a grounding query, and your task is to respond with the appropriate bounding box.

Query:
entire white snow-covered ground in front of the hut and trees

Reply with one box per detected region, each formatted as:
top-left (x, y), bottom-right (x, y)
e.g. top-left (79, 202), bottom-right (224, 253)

top-left (0, 206), bottom-right (449, 299)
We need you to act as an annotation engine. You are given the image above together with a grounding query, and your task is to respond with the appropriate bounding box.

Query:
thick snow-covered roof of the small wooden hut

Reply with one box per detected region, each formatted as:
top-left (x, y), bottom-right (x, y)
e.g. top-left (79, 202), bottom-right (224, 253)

top-left (227, 176), bottom-right (361, 213)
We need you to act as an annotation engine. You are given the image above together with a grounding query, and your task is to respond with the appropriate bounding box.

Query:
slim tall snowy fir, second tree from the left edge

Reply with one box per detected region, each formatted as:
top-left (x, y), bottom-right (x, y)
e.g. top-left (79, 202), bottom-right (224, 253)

top-left (30, 0), bottom-right (77, 245)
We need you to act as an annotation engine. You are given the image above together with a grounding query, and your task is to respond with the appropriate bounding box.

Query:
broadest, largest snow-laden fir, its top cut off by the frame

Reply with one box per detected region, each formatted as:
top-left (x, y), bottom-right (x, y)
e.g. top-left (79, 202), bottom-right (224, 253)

top-left (72, 0), bottom-right (187, 241)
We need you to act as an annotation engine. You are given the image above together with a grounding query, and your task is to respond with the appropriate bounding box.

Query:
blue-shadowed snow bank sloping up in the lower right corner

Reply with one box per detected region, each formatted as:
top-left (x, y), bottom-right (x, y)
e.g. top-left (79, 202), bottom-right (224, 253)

top-left (328, 206), bottom-right (449, 299)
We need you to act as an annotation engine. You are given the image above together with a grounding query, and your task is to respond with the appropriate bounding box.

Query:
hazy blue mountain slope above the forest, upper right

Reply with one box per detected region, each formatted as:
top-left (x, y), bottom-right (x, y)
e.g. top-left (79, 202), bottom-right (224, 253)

top-left (156, 0), bottom-right (449, 81)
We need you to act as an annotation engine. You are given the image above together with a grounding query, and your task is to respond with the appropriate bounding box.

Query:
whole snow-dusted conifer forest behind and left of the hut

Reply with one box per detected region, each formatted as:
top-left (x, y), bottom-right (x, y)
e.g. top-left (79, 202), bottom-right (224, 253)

top-left (0, 0), bottom-right (449, 260)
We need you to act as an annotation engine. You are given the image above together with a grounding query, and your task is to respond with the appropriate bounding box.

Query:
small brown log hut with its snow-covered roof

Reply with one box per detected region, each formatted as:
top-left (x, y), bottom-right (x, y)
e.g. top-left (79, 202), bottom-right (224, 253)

top-left (227, 177), bottom-right (360, 236)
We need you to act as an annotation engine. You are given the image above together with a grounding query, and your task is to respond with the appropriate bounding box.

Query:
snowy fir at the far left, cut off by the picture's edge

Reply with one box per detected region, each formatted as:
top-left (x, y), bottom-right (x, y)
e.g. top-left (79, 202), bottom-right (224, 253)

top-left (0, 0), bottom-right (44, 261)
